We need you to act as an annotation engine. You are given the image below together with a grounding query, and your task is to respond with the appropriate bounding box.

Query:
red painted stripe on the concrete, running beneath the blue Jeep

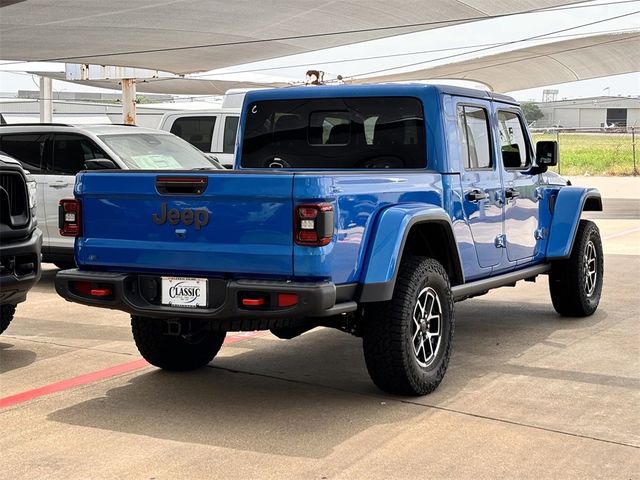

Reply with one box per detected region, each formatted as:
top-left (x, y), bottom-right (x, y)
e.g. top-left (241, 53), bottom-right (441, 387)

top-left (0, 332), bottom-right (264, 408)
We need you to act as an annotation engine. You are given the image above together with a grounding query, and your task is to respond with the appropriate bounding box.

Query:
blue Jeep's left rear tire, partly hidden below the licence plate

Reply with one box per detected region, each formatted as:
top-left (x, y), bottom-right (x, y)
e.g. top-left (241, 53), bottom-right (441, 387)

top-left (131, 315), bottom-right (227, 371)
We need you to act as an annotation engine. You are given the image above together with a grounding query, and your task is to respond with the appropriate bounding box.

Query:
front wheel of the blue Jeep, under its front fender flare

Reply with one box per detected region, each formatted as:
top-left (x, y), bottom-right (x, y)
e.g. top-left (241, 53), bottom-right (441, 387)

top-left (549, 220), bottom-right (604, 317)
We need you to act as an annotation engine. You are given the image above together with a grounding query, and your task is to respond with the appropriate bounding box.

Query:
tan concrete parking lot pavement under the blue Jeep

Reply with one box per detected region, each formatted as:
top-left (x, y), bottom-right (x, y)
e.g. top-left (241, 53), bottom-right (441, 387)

top-left (0, 182), bottom-right (640, 479)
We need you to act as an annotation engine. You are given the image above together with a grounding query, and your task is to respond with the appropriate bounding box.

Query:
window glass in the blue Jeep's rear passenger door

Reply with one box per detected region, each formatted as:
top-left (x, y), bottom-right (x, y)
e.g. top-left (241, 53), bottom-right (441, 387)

top-left (458, 105), bottom-right (492, 170)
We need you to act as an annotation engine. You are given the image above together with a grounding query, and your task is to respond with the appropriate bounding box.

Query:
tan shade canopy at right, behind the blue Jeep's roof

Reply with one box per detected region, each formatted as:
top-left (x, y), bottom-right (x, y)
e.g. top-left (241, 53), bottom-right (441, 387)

top-left (351, 31), bottom-right (640, 92)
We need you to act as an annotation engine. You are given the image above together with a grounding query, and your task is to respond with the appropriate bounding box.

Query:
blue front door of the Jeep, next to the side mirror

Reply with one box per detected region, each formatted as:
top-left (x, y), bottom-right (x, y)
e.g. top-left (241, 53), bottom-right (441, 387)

top-left (497, 106), bottom-right (539, 263)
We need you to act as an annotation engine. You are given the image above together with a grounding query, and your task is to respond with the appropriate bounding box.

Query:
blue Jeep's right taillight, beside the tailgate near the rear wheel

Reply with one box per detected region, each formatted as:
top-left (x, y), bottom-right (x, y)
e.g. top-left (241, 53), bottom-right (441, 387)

top-left (294, 203), bottom-right (333, 247)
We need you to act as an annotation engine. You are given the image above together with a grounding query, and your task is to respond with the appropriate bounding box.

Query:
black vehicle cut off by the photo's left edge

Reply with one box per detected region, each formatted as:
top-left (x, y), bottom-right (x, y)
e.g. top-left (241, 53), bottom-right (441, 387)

top-left (0, 153), bottom-right (42, 333)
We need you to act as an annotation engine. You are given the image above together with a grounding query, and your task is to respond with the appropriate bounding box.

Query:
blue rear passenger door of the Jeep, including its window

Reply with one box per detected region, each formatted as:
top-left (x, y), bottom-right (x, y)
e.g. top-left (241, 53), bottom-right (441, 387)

top-left (456, 99), bottom-right (504, 268)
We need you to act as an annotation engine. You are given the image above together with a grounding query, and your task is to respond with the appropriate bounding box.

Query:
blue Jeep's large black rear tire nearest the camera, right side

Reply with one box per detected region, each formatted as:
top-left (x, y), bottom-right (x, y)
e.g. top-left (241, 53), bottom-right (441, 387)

top-left (362, 257), bottom-right (454, 395)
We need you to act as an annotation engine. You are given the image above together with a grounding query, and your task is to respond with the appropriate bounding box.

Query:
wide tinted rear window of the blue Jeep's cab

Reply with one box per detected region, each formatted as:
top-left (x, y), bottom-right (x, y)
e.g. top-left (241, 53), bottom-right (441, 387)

top-left (240, 97), bottom-right (427, 169)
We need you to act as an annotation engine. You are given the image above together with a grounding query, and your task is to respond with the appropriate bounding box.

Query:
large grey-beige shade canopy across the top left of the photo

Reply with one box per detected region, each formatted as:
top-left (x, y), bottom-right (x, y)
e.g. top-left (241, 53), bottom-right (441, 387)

top-left (0, 0), bottom-right (578, 74)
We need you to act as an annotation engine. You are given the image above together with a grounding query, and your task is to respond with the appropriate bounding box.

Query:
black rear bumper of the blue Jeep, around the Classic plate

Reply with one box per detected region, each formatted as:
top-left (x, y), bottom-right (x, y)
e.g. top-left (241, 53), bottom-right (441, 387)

top-left (55, 269), bottom-right (341, 320)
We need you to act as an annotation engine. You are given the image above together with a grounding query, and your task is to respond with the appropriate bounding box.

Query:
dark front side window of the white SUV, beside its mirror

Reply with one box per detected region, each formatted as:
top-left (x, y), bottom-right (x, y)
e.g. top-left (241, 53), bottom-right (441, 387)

top-left (48, 134), bottom-right (105, 175)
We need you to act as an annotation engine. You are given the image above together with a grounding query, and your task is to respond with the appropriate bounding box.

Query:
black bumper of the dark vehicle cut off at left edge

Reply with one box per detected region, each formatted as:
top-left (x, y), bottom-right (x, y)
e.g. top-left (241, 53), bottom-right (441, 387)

top-left (0, 228), bottom-right (42, 304)
